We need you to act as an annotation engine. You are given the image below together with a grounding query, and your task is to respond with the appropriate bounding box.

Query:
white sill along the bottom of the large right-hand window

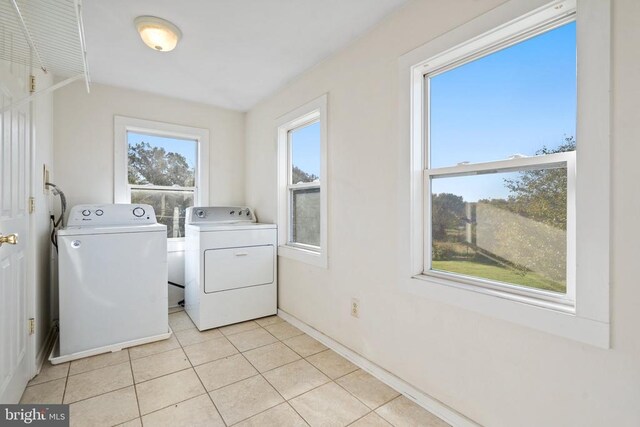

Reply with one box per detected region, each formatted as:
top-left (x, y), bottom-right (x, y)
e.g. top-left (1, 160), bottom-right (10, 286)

top-left (405, 274), bottom-right (609, 349)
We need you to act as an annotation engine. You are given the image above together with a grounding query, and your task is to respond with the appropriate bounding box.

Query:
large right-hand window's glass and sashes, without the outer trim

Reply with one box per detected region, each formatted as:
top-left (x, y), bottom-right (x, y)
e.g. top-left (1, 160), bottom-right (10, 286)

top-left (423, 20), bottom-right (576, 305)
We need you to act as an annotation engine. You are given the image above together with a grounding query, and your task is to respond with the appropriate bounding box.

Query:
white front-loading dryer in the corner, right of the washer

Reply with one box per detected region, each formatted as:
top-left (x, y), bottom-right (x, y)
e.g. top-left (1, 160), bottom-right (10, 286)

top-left (185, 206), bottom-right (278, 331)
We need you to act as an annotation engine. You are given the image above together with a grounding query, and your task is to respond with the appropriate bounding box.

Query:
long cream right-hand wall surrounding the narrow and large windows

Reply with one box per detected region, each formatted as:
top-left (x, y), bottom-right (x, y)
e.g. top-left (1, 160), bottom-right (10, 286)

top-left (245, 0), bottom-right (640, 426)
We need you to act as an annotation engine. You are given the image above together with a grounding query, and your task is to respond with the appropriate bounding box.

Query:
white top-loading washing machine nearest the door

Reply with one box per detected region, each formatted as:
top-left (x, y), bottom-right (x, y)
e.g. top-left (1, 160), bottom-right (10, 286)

top-left (51, 204), bottom-right (171, 363)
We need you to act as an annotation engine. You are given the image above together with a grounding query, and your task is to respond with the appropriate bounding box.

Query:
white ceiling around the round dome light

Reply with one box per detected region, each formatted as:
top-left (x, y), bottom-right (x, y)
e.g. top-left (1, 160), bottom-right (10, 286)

top-left (84, 0), bottom-right (407, 111)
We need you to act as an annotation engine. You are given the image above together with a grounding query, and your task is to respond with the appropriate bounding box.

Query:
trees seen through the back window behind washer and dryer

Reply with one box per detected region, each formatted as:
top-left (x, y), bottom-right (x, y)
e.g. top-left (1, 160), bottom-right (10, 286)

top-left (128, 141), bottom-right (195, 238)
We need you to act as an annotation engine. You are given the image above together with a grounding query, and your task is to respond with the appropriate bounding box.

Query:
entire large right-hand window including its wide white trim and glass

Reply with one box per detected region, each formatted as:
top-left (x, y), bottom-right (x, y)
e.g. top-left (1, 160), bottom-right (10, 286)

top-left (401, 0), bottom-right (610, 347)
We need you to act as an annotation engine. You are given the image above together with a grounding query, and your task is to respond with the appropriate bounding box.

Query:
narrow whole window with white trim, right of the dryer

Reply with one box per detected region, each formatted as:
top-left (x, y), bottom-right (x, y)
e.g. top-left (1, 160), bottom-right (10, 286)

top-left (278, 96), bottom-right (327, 266)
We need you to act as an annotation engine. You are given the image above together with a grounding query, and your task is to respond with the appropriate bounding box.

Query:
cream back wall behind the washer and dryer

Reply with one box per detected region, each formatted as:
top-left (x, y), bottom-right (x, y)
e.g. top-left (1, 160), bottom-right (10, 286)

top-left (54, 82), bottom-right (245, 305)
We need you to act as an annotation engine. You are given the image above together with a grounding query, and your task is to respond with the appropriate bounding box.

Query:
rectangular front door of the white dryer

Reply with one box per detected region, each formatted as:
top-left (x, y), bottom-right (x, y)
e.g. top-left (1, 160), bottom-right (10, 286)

top-left (204, 245), bottom-right (274, 294)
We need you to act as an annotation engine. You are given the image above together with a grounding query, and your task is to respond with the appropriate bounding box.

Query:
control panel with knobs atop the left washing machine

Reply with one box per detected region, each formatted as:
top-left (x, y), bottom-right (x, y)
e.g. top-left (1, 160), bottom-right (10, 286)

top-left (67, 204), bottom-right (157, 227)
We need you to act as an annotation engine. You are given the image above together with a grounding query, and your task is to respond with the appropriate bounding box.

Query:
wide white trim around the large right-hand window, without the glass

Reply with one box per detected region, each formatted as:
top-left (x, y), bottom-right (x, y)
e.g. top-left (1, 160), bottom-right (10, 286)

top-left (399, 0), bottom-right (611, 348)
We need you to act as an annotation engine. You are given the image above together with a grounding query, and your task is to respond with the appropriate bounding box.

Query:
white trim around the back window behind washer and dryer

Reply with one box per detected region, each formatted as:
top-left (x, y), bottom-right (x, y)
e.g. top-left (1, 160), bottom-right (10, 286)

top-left (113, 116), bottom-right (209, 252)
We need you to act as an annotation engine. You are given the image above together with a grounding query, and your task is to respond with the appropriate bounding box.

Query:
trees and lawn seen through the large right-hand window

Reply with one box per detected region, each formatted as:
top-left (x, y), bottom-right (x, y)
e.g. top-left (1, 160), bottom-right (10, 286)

top-left (432, 137), bottom-right (576, 292)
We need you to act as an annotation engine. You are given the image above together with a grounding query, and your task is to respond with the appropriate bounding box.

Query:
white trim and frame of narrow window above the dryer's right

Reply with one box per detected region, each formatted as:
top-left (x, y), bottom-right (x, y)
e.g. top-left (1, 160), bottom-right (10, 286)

top-left (276, 94), bottom-right (328, 268)
